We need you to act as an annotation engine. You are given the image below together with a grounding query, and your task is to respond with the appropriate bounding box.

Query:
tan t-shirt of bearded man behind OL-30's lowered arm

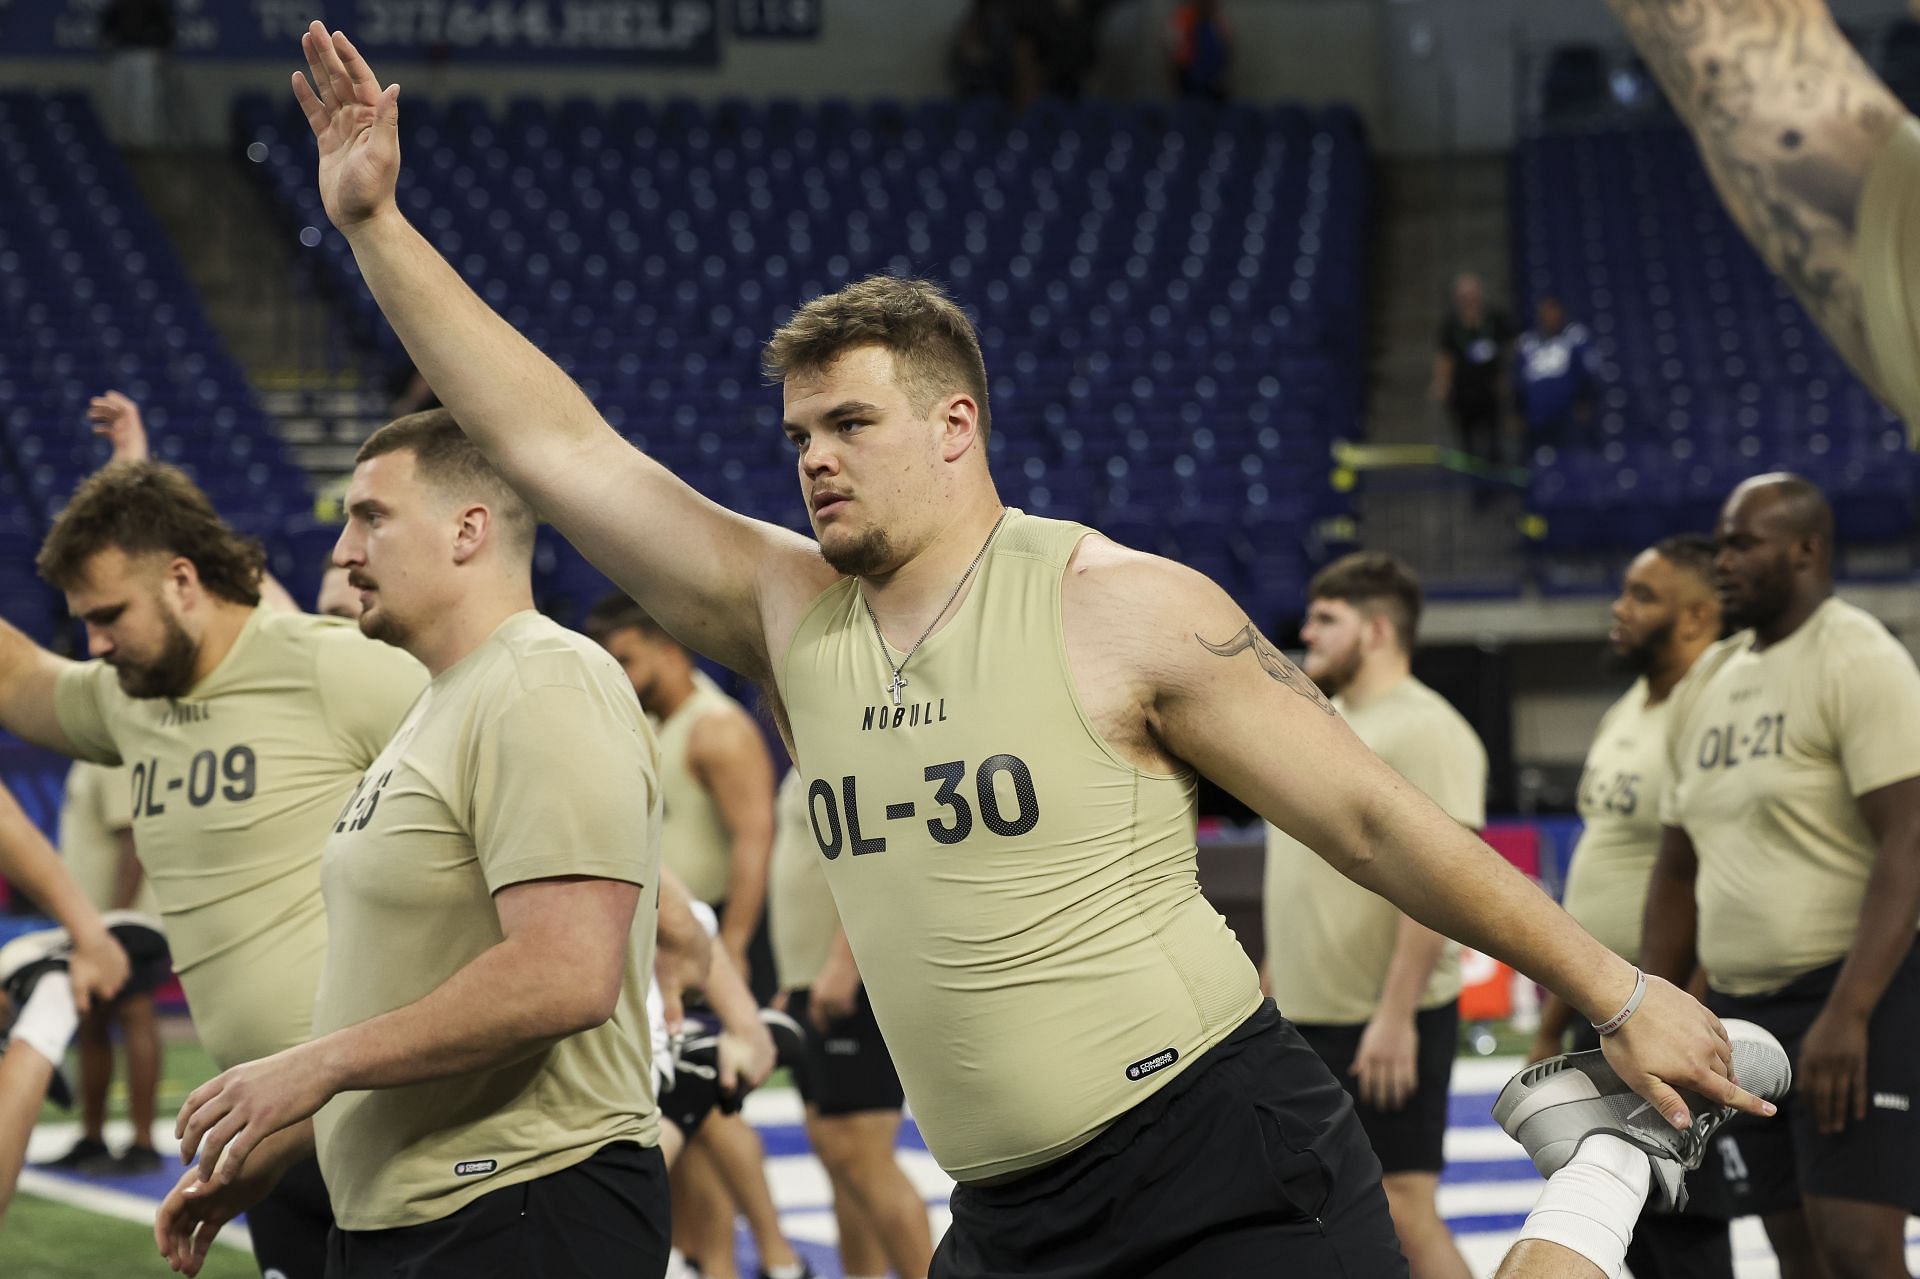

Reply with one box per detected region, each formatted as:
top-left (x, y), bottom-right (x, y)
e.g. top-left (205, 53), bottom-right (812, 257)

top-left (1263, 676), bottom-right (1486, 1026)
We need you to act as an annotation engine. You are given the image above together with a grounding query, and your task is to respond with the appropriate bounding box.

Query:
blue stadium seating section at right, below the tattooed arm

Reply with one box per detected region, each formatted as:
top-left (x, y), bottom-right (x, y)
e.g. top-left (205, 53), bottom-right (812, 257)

top-left (1513, 125), bottom-right (1914, 567)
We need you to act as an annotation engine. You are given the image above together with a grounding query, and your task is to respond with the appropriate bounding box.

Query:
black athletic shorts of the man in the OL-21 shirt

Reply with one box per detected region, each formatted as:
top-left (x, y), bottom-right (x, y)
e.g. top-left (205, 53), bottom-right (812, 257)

top-left (1707, 925), bottom-right (1920, 1214)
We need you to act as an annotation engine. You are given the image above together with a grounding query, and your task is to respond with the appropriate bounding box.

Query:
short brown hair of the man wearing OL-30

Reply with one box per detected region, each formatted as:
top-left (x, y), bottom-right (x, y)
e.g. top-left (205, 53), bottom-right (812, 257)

top-left (760, 275), bottom-right (991, 440)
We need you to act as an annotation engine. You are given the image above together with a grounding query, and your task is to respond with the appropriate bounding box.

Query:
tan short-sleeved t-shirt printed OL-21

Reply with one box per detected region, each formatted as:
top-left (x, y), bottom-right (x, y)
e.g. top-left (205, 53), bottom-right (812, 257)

top-left (1661, 599), bottom-right (1920, 995)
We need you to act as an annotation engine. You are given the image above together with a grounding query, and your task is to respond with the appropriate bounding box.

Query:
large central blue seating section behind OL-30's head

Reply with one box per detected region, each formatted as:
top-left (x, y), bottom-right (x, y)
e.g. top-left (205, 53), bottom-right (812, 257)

top-left (236, 98), bottom-right (1369, 618)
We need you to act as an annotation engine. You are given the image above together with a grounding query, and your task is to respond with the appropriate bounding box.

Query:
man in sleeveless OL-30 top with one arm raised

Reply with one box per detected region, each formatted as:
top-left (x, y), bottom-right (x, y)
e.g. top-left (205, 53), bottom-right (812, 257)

top-left (294, 23), bottom-right (1768, 1279)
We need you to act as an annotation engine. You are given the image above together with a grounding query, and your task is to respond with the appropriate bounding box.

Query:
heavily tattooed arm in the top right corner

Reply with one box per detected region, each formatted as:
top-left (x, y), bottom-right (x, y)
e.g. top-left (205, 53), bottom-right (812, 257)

top-left (1609, 0), bottom-right (1907, 386)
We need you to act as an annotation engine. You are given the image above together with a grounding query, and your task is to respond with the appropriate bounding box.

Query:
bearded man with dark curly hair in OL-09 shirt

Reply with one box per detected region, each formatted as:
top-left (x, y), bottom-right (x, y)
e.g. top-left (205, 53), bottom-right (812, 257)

top-left (0, 461), bottom-right (426, 1279)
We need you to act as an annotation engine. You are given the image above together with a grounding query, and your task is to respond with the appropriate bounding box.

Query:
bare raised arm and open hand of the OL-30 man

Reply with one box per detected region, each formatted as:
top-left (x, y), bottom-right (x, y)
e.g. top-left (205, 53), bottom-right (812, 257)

top-left (294, 23), bottom-right (833, 678)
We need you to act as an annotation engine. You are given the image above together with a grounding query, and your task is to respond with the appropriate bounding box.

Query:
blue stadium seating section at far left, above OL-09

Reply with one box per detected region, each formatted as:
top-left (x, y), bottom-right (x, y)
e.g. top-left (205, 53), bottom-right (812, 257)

top-left (0, 94), bottom-right (311, 640)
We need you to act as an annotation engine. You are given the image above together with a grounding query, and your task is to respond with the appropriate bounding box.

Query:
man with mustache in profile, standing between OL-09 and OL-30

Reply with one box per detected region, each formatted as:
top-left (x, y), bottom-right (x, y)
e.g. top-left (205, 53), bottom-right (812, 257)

top-left (156, 409), bottom-right (675, 1279)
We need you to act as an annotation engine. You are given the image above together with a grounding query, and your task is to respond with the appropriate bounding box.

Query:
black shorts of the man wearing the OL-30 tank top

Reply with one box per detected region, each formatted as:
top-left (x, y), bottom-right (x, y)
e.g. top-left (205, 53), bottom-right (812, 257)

top-left (931, 1001), bottom-right (1407, 1279)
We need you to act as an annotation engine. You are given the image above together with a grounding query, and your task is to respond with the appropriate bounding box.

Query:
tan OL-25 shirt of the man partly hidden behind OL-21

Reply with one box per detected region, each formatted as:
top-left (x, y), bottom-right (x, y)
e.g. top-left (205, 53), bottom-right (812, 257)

top-left (1563, 680), bottom-right (1672, 960)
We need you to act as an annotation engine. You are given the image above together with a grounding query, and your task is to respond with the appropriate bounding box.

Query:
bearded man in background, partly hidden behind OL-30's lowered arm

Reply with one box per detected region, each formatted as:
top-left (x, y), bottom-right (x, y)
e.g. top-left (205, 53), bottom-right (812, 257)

top-left (1263, 551), bottom-right (1486, 1279)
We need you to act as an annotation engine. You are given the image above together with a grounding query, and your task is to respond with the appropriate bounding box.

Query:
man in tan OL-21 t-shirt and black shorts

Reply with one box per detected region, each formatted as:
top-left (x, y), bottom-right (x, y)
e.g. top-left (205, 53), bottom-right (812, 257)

top-left (1640, 474), bottom-right (1920, 1279)
